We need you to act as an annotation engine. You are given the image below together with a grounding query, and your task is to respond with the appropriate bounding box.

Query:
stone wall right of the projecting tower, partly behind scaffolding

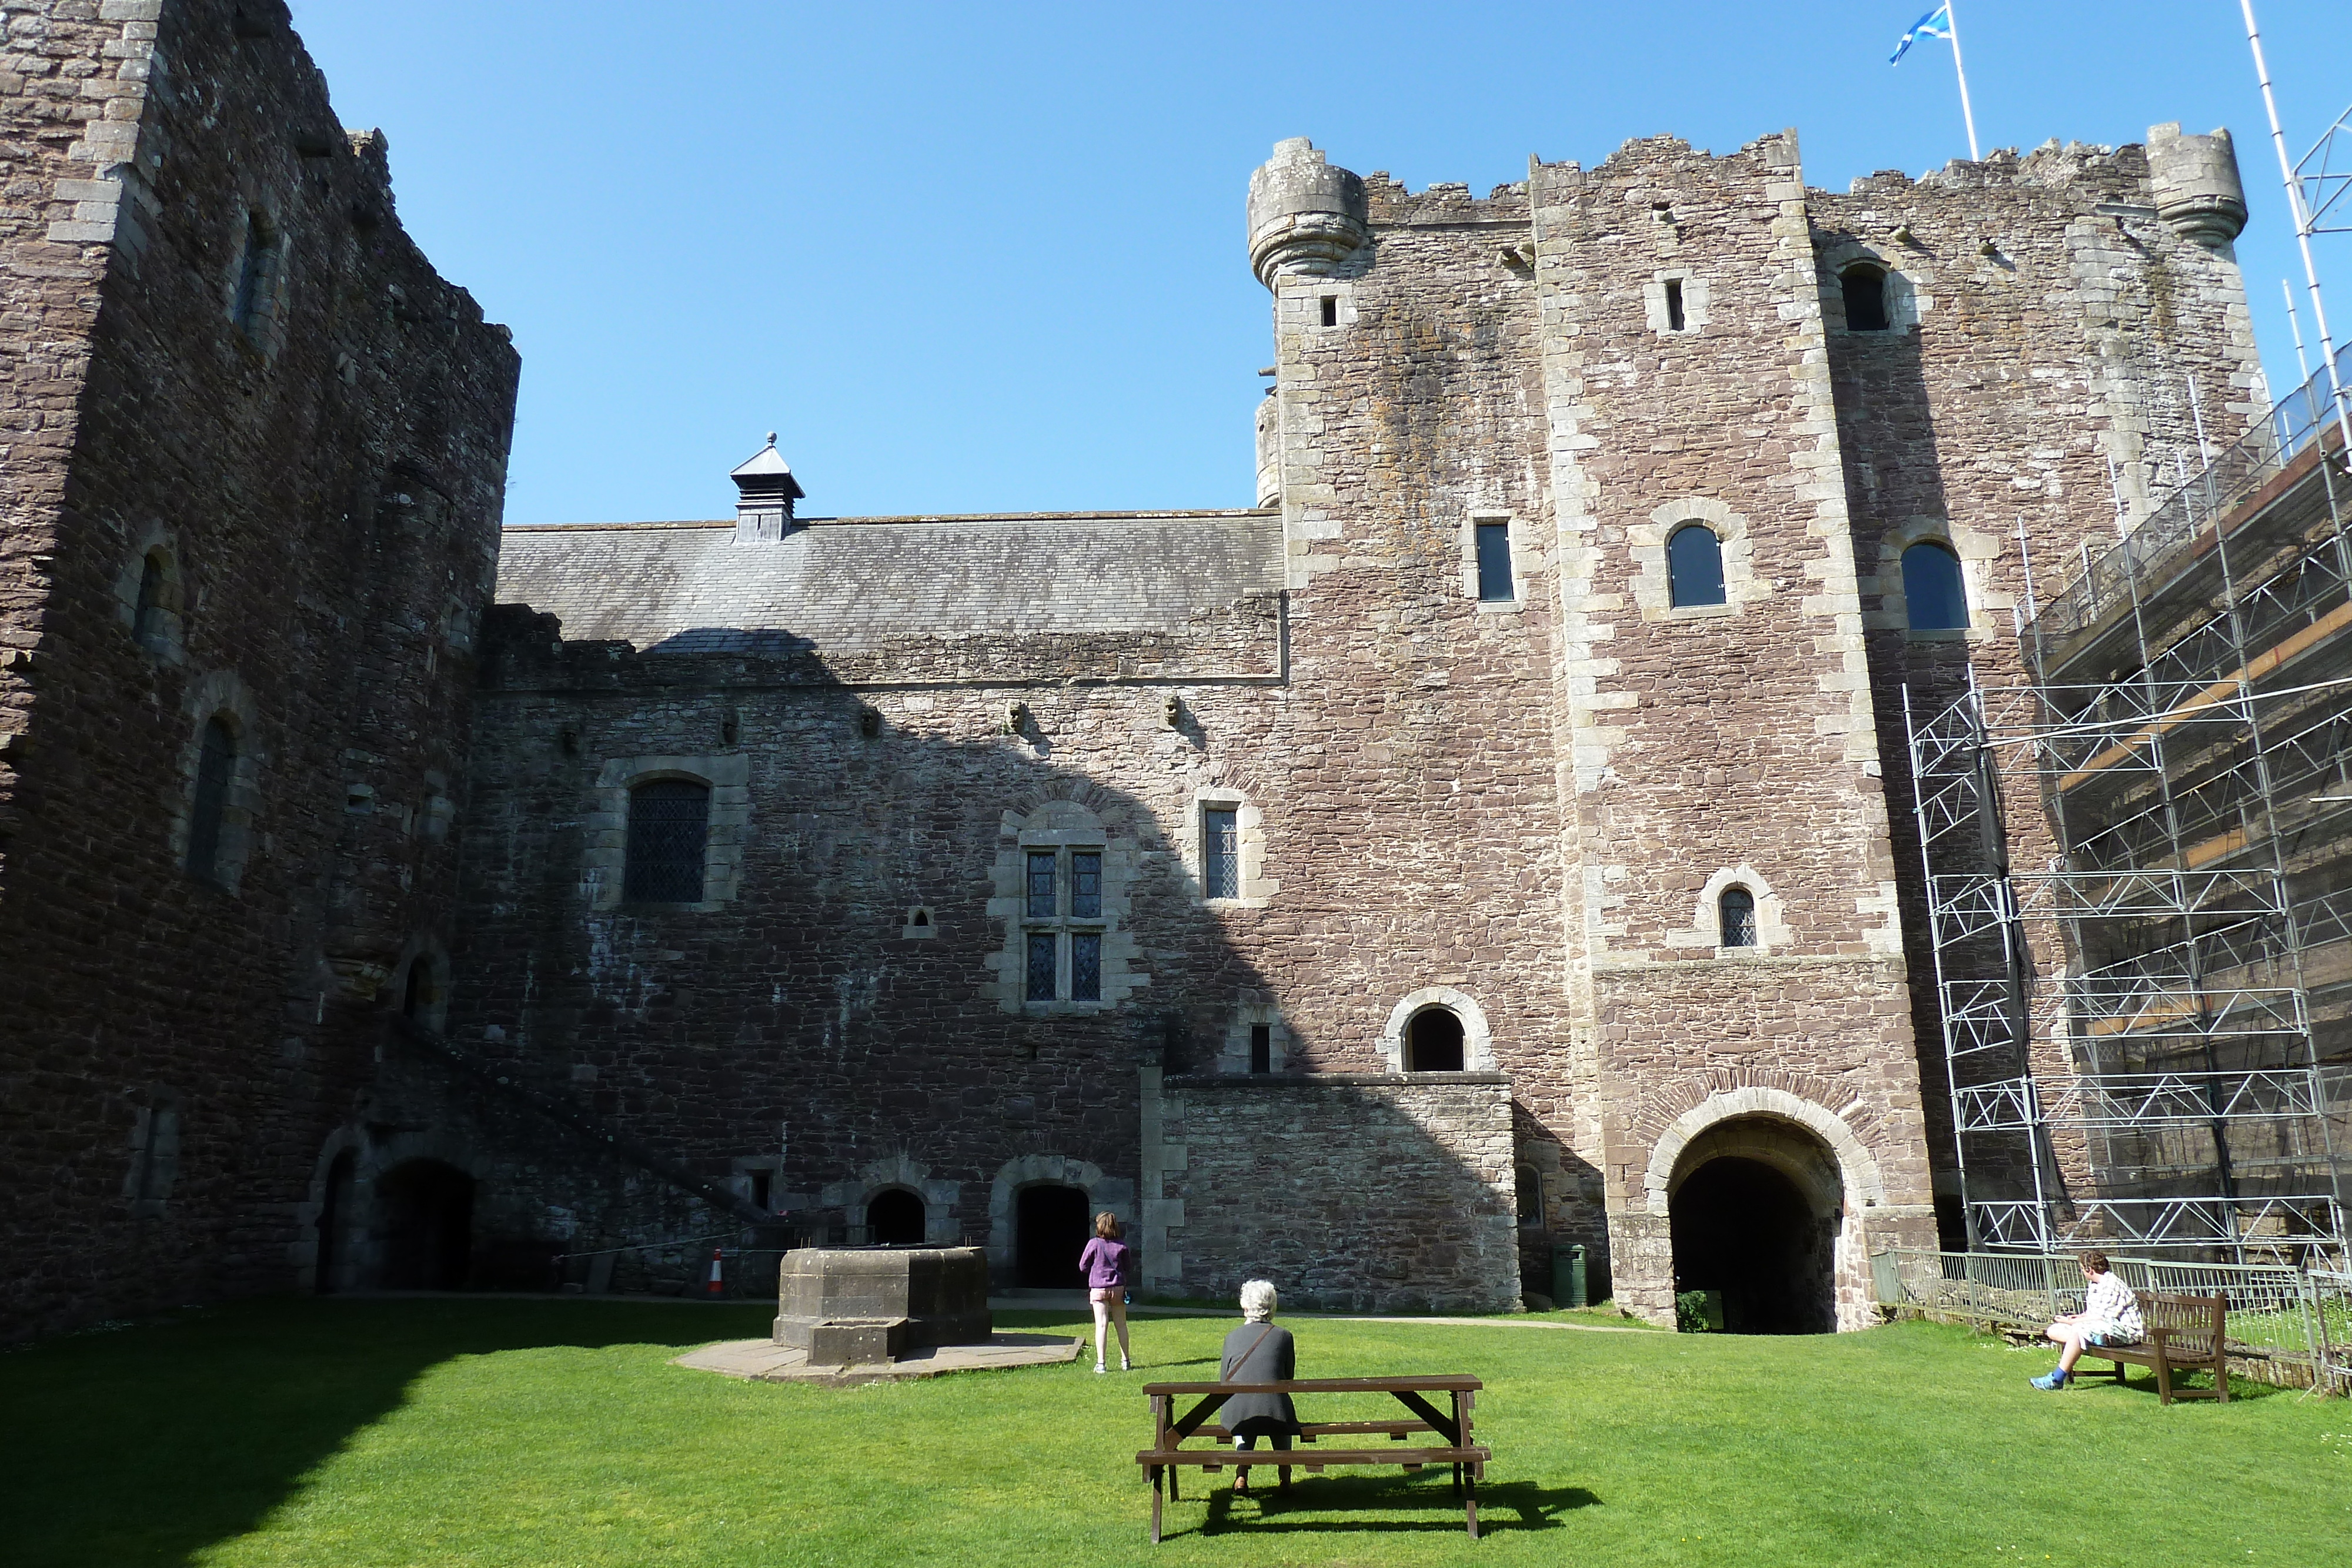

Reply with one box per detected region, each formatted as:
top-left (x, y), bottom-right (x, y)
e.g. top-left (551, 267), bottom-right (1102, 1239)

top-left (1811, 141), bottom-right (2267, 1213)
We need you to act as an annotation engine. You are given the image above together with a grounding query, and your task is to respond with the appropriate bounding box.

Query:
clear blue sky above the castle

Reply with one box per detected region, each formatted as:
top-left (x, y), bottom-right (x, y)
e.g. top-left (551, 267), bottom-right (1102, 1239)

top-left (294, 0), bottom-right (2352, 522)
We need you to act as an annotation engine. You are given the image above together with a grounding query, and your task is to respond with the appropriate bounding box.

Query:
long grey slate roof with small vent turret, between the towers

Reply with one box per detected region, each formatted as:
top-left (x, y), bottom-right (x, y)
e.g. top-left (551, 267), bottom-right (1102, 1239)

top-left (499, 513), bottom-right (1282, 654)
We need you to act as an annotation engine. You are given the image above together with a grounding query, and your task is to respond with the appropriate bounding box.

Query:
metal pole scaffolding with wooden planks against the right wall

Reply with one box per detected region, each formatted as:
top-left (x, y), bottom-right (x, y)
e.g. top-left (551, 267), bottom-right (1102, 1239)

top-left (1903, 350), bottom-right (2352, 1262)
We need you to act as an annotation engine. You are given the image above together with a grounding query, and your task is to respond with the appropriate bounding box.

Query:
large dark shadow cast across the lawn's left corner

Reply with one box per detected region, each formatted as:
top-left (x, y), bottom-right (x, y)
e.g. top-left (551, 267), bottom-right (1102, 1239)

top-left (0, 1295), bottom-right (774, 1568)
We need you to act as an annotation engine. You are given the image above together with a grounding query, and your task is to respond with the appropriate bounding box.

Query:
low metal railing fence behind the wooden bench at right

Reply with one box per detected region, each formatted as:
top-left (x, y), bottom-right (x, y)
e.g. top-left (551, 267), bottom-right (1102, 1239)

top-left (1870, 1246), bottom-right (2352, 1394)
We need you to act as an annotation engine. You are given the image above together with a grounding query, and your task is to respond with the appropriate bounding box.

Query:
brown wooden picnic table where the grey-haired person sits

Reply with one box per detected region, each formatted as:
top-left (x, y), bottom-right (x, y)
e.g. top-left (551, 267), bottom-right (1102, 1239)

top-left (1136, 1375), bottom-right (1494, 1544)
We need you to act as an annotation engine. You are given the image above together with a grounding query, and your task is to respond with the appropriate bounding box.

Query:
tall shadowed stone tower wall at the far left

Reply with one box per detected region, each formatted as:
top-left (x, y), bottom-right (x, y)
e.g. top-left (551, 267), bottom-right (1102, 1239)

top-left (0, 0), bottom-right (517, 1333)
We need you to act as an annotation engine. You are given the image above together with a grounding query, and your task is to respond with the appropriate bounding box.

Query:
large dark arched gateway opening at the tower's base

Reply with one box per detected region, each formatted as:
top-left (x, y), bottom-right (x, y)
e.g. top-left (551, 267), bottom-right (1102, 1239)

top-left (1668, 1116), bottom-right (1844, 1333)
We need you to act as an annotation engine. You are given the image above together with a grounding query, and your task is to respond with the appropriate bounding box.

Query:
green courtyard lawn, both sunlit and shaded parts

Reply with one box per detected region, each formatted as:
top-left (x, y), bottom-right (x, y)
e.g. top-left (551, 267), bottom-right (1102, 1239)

top-left (0, 1300), bottom-right (2352, 1568)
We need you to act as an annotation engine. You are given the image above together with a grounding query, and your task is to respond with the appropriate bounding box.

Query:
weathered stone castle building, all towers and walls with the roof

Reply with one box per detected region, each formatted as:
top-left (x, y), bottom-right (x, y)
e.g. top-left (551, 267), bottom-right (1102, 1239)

top-left (0, 0), bottom-right (2263, 1330)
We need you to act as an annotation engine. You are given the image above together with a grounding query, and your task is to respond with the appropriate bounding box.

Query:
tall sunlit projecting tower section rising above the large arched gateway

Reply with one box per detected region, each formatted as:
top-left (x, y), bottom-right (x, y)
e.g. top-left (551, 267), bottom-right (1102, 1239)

top-left (1505, 134), bottom-right (1929, 1316)
